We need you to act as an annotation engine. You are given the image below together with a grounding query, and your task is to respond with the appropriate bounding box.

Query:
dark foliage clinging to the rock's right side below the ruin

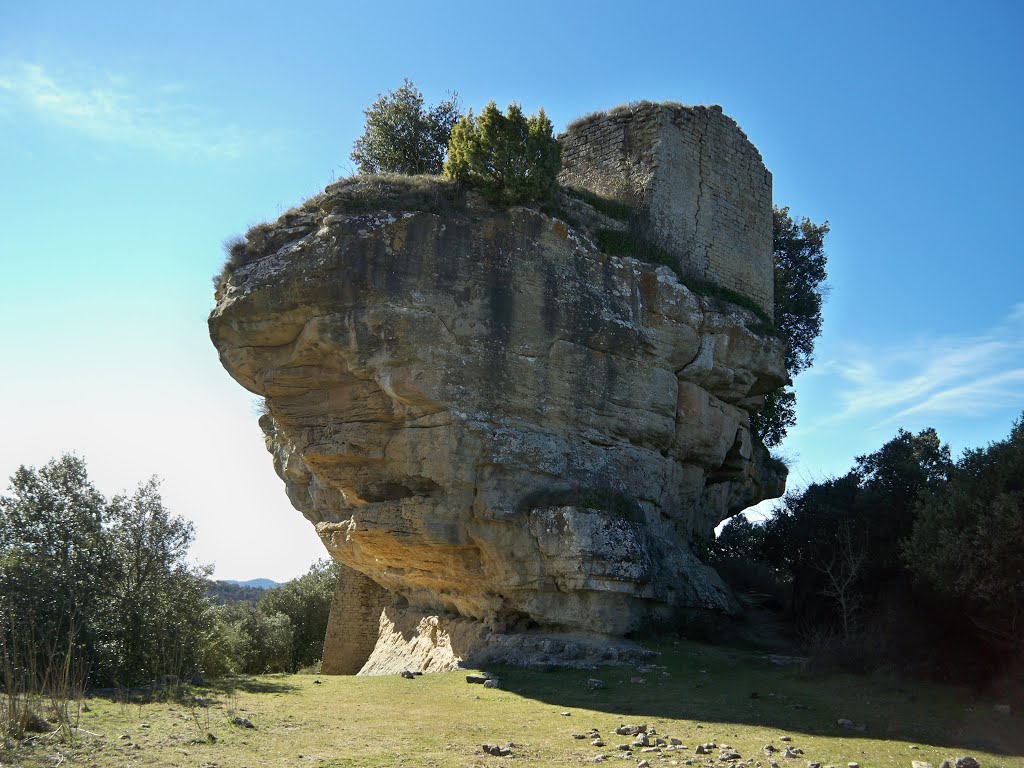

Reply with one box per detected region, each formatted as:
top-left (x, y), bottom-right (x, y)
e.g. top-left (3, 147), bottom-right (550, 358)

top-left (752, 207), bottom-right (828, 447)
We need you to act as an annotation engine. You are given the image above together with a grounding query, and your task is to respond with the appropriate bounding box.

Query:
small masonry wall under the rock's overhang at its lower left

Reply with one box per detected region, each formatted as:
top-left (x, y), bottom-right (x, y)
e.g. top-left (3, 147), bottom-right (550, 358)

top-left (321, 565), bottom-right (388, 675)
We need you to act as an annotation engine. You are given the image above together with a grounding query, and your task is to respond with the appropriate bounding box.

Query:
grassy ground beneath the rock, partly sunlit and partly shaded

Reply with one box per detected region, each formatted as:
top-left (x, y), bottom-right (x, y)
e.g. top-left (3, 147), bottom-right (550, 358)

top-left (0, 642), bottom-right (1024, 768)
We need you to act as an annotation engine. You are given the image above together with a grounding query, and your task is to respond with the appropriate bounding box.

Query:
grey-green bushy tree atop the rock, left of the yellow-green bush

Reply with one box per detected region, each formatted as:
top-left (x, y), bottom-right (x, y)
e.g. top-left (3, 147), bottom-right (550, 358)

top-left (351, 78), bottom-right (460, 175)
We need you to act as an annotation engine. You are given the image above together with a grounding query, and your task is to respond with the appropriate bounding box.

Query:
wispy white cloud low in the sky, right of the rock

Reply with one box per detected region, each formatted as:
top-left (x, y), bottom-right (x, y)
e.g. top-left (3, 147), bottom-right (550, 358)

top-left (806, 303), bottom-right (1024, 427)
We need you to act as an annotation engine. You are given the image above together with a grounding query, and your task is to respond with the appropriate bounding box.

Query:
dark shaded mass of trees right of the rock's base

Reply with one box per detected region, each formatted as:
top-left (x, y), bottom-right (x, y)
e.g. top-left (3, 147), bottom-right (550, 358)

top-left (724, 421), bottom-right (1024, 682)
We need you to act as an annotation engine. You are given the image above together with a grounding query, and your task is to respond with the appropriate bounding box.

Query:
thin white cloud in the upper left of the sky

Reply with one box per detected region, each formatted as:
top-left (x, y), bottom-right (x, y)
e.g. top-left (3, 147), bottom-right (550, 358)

top-left (0, 61), bottom-right (266, 157)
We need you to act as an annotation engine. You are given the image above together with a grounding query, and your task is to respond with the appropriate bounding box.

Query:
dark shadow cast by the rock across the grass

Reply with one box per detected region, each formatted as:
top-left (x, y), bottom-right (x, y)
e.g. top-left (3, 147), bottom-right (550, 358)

top-left (492, 641), bottom-right (1024, 756)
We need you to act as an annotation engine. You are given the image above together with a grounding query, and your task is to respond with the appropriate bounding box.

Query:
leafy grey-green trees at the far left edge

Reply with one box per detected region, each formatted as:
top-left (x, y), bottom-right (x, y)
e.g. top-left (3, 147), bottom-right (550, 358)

top-left (0, 456), bottom-right (211, 684)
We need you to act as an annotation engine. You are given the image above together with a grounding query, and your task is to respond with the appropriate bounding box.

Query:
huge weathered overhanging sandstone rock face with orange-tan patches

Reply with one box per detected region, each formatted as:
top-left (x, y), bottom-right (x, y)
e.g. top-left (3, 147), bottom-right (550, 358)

top-left (210, 180), bottom-right (786, 651)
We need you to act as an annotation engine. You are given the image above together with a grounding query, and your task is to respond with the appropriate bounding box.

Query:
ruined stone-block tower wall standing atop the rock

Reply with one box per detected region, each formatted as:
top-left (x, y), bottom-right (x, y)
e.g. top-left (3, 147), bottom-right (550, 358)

top-left (560, 102), bottom-right (774, 315)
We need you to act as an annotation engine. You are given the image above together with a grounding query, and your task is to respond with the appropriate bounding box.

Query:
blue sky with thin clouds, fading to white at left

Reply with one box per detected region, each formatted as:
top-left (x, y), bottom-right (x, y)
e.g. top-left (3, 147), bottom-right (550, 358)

top-left (0, 0), bottom-right (1024, 580)
